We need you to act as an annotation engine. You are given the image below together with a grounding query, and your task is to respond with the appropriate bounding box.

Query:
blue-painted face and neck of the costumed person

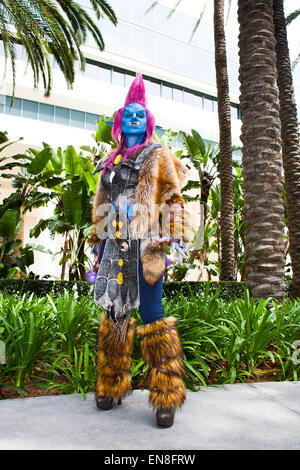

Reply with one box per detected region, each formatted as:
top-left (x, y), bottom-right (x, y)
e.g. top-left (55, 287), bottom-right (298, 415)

top-left (122, 103), bottom-right (147, 148)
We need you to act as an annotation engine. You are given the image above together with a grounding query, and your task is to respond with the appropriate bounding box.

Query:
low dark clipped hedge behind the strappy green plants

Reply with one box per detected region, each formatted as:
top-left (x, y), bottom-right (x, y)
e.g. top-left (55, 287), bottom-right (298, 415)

top-left (0, 279), bottom-right (291, 300)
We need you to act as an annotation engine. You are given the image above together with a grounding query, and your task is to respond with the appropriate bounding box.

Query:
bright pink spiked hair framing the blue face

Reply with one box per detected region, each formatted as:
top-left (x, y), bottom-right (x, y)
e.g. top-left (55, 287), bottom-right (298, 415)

top-left (103, 73), bottom-right (155, 173)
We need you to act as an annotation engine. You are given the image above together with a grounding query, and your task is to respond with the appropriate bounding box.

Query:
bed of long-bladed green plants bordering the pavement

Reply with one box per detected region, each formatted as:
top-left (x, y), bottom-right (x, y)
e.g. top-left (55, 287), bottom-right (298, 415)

top-left (0, 286), bottom-right (300, 397)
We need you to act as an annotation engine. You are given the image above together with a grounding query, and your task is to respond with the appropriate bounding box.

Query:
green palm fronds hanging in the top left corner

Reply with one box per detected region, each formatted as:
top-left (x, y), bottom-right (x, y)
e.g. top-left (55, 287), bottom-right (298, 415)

top-left (0, 0), bottom-right (117, 96)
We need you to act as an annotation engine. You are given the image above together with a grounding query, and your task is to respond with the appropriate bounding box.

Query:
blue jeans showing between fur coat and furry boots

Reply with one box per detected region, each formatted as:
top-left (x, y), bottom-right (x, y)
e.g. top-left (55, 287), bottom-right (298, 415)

top-left (95, 240), bottom-right (164, 324)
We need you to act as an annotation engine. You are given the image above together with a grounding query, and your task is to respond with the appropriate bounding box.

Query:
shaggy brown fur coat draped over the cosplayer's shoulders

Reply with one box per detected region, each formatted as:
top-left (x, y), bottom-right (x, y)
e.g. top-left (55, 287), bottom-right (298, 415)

top-left (93, 146), bottom-right (192, 285)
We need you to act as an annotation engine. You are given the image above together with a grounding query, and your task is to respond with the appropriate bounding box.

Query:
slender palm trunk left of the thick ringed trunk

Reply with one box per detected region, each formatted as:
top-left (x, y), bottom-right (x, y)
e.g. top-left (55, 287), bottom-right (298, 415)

top-left (214, 0), bottom-right (235, 281)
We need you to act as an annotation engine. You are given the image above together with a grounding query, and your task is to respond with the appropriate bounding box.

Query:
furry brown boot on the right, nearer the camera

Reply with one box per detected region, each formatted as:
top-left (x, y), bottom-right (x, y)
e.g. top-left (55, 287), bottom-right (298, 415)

top-left (136, 317), bottom-right (186, 427)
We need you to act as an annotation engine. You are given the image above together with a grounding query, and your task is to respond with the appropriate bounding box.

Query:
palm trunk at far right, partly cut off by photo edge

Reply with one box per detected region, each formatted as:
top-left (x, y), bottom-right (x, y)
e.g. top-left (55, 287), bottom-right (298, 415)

top-left (273, 0), bottom-right (300, 298)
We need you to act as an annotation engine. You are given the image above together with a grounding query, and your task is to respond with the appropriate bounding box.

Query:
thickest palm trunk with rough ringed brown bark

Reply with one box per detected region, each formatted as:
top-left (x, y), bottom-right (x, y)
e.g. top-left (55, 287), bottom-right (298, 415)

top-left (238, 0), bottom-right (285, 300)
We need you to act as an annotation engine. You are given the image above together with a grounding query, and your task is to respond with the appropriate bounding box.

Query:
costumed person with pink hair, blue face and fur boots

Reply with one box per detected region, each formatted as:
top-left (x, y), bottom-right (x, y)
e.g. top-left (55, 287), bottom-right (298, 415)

top-left (90, 74), bottom-right (190, 426)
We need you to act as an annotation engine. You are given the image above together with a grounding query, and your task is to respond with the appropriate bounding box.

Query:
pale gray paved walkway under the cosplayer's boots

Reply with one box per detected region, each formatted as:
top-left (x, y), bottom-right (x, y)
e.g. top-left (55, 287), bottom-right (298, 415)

top-left (0, 382), bottom-right (300, 450)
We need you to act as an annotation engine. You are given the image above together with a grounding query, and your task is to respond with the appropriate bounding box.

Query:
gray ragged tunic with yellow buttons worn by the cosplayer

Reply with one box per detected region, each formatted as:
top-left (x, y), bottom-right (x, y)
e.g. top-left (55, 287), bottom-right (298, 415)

top-left (94, 144), bottom-right (161, 319)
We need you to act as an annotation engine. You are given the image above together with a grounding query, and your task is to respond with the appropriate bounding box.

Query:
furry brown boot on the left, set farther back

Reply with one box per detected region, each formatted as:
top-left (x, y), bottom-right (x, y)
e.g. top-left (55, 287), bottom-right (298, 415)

top-left (95, 314), bottom-right (135, 410)
